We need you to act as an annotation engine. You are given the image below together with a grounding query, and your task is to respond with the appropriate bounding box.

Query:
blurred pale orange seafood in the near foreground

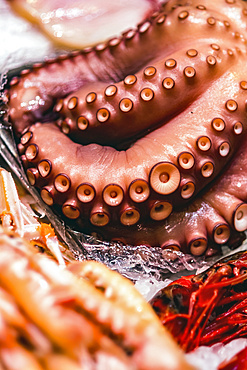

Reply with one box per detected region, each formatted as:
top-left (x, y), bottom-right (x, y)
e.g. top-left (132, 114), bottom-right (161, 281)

top-left (0, 228), bottom-right (192, 370)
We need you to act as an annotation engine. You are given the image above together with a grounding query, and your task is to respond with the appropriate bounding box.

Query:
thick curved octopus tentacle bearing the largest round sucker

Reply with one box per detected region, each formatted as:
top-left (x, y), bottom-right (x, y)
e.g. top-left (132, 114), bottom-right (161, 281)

top-left (18, 55), bottom-right (246, 226)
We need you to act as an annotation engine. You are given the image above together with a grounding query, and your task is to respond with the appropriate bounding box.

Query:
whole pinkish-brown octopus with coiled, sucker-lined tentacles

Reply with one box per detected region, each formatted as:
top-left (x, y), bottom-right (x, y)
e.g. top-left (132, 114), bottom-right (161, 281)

top-left (5, 0), bottom-right (247, 256)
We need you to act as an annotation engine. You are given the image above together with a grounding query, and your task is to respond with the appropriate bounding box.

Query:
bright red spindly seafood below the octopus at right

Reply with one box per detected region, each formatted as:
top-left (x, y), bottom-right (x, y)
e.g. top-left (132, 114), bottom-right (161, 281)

top-left (151, 251), bottom-right (247, 352)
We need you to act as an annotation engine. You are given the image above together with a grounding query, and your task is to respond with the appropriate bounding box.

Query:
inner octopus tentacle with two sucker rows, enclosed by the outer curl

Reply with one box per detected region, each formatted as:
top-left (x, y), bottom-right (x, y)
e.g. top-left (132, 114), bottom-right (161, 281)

top-left (55, 42), bottom-right (241, 145)
